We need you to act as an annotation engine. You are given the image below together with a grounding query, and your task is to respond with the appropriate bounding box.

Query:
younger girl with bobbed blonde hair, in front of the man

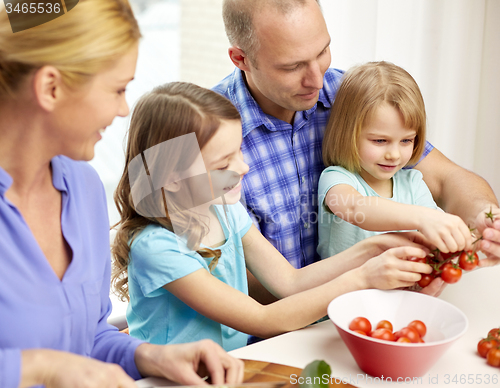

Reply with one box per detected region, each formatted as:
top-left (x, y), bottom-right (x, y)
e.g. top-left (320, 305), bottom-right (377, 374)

top-left (318, 62), bottom-right (472, 258)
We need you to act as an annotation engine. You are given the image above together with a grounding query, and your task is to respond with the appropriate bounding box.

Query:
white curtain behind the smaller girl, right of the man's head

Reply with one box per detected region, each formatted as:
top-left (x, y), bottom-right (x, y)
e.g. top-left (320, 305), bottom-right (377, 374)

top-left (321, 0), bottom-right (500, 196)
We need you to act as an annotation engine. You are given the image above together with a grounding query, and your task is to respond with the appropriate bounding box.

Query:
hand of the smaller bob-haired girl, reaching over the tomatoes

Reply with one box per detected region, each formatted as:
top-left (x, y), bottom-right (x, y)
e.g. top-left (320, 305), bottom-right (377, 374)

top-left (418, 208), bottom-right (472, 253)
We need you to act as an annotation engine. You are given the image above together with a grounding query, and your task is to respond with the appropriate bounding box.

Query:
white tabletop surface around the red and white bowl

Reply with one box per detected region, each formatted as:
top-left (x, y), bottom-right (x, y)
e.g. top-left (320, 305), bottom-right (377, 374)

top-left (230, 266), bottom-right (500, 388)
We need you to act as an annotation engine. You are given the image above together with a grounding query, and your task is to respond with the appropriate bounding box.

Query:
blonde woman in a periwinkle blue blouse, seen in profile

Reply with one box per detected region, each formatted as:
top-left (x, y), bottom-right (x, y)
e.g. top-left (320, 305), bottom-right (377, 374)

top-left (0, 0), bottom-right (243, 388)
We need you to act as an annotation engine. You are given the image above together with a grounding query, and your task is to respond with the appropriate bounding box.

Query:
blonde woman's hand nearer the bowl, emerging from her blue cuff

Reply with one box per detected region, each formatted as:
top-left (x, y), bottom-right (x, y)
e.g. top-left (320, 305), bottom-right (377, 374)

top-left (135, 340), bottom-right (244, 385)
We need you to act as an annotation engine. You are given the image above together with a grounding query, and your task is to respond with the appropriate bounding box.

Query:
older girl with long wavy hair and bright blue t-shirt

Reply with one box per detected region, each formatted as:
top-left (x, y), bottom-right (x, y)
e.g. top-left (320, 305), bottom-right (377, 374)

top-left (113, 83), bottom-right (436, 350)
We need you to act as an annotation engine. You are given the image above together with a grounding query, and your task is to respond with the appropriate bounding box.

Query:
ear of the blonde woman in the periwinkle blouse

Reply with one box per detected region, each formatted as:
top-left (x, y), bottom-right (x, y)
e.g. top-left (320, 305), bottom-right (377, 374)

top-left (33, 66), bottom-right (63, 112)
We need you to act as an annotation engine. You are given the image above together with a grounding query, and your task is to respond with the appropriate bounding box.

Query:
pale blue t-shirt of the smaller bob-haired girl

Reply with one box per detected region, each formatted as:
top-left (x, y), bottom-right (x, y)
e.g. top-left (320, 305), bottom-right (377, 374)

top-left (318, 166), bottom-right (437, 259)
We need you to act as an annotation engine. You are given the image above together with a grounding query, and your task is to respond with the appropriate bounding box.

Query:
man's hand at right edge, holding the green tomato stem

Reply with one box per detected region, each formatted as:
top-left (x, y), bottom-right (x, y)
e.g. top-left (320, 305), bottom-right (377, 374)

top-left (476, 205), bottom-right (500, 267)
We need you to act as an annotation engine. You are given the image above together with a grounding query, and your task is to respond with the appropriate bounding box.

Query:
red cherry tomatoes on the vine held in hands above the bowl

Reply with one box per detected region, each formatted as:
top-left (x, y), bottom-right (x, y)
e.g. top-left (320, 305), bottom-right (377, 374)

top-left (412, 250), bottom-right (479, 288)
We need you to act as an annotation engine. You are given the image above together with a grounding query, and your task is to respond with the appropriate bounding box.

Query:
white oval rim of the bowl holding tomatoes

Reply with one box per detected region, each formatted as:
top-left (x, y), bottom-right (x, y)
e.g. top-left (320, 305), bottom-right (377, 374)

top-left (327, 288), bottom-right (469, 348)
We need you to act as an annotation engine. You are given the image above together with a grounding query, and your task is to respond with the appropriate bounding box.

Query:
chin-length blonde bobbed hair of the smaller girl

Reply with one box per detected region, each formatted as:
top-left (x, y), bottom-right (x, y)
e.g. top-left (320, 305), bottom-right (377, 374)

top-left (323, 61), bottom-right (426, 173)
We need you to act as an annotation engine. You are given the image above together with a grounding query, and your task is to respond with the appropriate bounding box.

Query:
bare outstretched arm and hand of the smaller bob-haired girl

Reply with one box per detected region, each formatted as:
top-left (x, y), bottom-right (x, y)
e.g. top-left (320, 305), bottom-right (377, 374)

top-left (325, 184), bottom-right (472, 252)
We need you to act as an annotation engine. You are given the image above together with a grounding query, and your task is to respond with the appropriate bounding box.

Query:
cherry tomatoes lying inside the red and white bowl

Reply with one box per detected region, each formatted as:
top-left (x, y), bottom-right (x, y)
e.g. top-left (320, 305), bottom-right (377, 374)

top-left (349, 317), bottom-right (427, 343)
